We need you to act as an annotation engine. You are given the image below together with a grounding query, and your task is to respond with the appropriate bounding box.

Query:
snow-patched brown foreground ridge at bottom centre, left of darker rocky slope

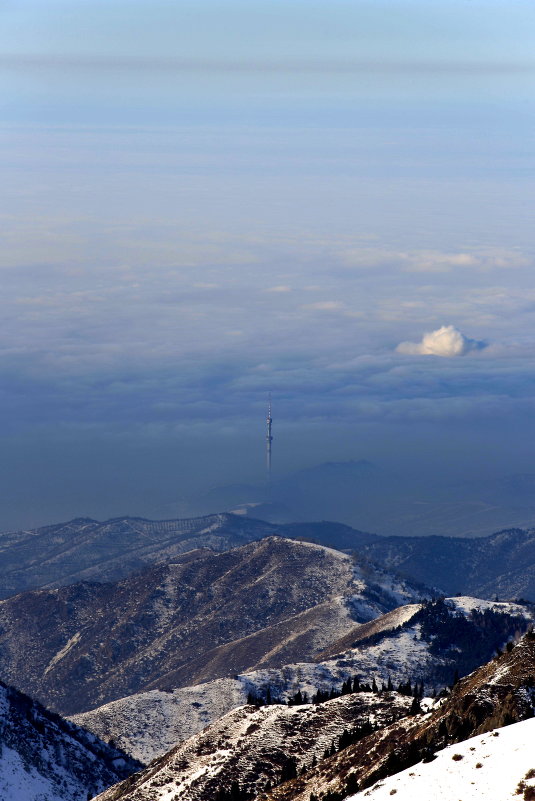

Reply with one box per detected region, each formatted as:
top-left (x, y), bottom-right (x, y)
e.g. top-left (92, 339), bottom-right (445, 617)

top-left (93, 693), bottom-right (411, 801)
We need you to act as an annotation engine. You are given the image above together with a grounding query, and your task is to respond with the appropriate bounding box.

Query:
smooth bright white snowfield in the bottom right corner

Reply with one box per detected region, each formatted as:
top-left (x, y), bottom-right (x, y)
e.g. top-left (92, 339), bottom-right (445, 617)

top-left (350, 718), bottom-right (535, 801)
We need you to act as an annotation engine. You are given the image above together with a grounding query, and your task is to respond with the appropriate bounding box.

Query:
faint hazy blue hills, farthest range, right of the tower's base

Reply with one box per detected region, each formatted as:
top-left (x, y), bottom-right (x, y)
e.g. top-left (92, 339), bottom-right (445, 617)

top-left (185, 459), bottom-right (535, 537)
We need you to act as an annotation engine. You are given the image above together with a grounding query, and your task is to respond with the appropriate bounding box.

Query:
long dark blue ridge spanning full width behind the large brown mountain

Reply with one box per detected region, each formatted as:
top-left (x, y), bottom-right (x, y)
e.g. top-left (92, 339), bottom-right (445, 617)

top-left (5, 513), bottom-right (535, 600)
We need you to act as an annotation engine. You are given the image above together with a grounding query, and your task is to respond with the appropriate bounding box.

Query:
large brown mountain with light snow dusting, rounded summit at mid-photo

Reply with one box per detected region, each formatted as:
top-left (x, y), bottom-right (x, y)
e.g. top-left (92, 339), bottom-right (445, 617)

top-left (0, 537), bottom-right (430, 714)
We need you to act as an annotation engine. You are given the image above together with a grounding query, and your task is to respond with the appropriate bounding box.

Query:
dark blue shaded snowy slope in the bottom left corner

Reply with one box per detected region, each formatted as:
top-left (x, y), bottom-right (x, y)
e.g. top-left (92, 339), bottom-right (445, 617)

top-left (0, 682), bottom-right (141, 801)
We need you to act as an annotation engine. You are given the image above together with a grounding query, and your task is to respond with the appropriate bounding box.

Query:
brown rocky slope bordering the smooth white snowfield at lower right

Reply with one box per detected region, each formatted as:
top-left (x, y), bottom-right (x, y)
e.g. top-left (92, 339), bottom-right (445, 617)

top-left (269, 633), bottom-right (535, 801)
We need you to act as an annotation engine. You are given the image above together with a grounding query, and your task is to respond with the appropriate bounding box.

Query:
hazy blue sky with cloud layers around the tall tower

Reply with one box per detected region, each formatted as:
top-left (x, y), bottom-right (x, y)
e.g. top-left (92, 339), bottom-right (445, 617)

top-left (0, 0), bottom-right (535, 530)
